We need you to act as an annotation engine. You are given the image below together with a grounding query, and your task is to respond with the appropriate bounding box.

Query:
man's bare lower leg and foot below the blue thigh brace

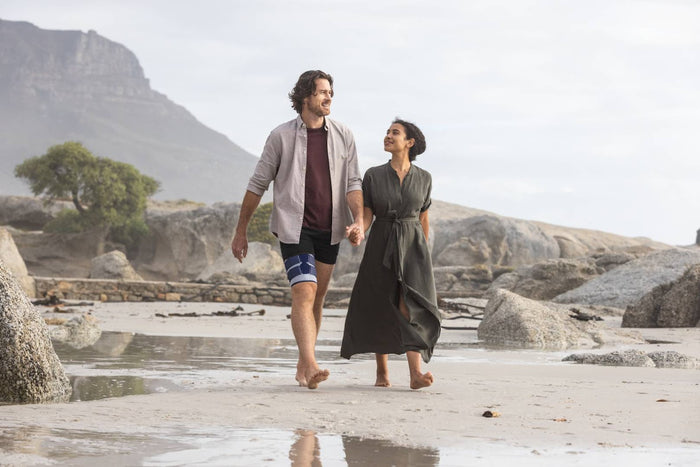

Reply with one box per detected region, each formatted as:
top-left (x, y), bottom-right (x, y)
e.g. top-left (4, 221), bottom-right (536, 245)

top-left (292, 282), bottom-right (329, 389)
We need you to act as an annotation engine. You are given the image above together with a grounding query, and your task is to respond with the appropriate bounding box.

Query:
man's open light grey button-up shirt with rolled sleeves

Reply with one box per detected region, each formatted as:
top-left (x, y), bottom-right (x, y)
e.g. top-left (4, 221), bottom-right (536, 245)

top-left (248, 116), bottom-right (362, 244)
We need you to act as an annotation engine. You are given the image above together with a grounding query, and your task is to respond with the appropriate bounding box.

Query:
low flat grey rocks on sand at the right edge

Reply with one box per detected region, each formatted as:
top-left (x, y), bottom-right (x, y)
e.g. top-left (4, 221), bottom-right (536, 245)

top-left (563, 349), bottom-right (700, 369)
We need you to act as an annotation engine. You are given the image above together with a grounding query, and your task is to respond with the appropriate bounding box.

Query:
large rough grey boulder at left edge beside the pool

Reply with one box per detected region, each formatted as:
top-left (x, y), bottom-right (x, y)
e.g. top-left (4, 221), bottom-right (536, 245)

top-left (0, 260), bottom-right (71, 403)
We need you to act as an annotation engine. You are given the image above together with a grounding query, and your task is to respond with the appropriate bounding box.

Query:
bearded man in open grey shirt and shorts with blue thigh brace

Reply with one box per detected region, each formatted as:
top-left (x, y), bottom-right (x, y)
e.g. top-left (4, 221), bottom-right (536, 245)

top-left (231, 70), bottom-right (364, 389)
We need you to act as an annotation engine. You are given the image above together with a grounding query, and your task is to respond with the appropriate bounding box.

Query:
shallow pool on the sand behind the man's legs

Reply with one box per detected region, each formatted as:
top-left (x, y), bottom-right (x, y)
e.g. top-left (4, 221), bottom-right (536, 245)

top-left (53, 332), bottom-right (340, 401)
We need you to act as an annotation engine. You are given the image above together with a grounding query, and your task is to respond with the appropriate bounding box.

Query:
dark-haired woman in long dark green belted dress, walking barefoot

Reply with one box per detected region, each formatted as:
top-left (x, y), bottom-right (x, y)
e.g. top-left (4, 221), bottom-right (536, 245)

top-left (340, 119), bottom-right (440, 389)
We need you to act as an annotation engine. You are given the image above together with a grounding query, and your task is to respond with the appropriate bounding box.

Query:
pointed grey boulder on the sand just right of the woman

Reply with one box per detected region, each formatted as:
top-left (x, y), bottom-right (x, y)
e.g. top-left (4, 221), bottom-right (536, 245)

top-left (477, 290), bottom-right (644, 349)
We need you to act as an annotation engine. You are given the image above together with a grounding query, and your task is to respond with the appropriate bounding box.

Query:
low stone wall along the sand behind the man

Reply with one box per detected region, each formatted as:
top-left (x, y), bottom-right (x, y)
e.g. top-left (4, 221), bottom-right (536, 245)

top-left (34, 277), bottom-right (350, 308)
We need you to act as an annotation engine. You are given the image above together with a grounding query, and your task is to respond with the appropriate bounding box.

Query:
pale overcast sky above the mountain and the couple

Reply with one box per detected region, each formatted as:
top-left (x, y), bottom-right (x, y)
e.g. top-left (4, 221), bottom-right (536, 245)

top-left (0, 0), bottom-right (700, 245)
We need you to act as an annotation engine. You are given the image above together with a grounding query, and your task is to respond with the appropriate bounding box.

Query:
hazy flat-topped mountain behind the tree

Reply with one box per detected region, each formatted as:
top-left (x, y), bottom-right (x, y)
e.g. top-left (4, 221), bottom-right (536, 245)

top-left (0, 20), bottom-right (257, 203)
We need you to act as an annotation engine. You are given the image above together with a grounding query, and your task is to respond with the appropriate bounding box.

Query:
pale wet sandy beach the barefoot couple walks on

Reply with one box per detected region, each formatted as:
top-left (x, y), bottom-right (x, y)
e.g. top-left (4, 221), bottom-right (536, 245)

top-left (0, 302), bottom-right (700, 465)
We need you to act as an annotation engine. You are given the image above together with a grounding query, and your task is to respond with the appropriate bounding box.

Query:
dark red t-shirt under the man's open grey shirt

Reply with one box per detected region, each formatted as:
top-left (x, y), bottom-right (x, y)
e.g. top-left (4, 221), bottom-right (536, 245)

top-left (302, 127), bottom-right (333, 231)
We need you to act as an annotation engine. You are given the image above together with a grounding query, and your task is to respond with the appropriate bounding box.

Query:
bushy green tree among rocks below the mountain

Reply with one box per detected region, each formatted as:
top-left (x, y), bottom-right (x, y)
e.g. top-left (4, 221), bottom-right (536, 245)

top-left (15, 141), bottom-right (160, 252)
